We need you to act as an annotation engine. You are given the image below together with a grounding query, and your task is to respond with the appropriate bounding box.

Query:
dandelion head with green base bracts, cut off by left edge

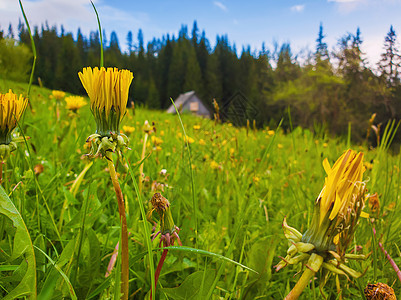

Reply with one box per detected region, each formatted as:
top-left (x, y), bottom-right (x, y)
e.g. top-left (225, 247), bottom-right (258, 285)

top-left (0, 90), bottom-right (28, 161)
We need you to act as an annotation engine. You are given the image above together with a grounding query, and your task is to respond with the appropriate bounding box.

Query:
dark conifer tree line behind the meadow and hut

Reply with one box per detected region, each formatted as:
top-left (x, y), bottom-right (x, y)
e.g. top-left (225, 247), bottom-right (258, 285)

top-left (0, 21), bottom-right (401, 139)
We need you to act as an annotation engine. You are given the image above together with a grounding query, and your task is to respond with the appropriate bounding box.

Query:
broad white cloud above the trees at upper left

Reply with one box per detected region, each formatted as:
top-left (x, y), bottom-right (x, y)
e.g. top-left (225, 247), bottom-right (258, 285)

top-left (0, 0), bottom-right (147, 48)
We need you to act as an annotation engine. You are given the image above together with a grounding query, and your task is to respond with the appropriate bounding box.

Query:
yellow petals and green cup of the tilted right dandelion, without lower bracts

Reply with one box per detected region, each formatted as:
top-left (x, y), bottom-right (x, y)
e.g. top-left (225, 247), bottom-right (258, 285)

top-left (302, 150), bottom-right (365, 255)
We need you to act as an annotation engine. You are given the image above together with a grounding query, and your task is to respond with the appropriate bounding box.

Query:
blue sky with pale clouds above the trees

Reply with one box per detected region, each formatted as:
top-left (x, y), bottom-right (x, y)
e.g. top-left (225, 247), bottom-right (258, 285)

top-left (0, 0), bottom-right (401, 66)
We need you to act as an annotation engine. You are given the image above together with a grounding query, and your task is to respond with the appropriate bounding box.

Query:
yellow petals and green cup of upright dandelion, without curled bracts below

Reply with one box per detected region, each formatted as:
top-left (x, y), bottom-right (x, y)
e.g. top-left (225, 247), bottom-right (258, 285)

top-left (78, 67), bottom-right (134, 136)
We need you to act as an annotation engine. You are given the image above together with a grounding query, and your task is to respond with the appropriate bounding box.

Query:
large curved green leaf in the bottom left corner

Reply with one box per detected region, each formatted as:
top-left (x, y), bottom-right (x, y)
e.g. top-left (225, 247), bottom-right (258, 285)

top-left (0, 186), bottom-right (36, 300)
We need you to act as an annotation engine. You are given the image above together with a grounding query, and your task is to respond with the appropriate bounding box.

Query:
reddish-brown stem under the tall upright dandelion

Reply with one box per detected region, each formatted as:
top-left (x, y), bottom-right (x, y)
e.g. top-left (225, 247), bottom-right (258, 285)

top-left (106, 152), bottom-right (129, 300)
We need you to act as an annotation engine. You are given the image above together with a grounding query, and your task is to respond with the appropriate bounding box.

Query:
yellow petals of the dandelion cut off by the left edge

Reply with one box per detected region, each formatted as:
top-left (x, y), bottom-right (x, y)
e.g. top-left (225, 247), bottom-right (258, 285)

top-left (0, 90), bottom-right (28, 145)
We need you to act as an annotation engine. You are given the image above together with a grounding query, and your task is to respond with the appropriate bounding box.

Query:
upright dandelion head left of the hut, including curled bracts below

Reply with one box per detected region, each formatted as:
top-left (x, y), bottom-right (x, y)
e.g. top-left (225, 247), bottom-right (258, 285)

top-left (78, 67), bottom-right (133, 156)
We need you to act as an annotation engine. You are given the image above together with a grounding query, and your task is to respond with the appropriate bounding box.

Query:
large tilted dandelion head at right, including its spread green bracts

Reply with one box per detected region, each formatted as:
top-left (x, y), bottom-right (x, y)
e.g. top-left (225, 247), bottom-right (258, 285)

top-left (276, 150), bottom-right (365, 295)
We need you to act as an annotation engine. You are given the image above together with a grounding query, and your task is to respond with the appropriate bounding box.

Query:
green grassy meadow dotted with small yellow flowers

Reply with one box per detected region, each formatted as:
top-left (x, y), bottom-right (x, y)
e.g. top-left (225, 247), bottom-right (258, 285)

top-left (0, 81), bottom-right (401, 299)
